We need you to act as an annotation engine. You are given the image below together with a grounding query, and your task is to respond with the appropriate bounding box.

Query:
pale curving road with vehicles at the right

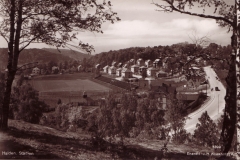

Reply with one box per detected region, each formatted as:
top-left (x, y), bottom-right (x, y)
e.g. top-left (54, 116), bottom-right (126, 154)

top-left (185, 66), bottom-right (226, 133)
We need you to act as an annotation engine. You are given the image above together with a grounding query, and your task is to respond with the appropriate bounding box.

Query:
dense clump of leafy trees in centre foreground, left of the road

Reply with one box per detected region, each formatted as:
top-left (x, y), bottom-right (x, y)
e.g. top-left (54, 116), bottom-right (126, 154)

top-left (87, 93), bottom-right (167, 142)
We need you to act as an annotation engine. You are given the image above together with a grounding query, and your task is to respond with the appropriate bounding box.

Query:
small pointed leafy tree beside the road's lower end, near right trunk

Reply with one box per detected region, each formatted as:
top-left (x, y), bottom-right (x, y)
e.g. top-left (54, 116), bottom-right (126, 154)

top-left (193, 111), bottom-right (220, 147)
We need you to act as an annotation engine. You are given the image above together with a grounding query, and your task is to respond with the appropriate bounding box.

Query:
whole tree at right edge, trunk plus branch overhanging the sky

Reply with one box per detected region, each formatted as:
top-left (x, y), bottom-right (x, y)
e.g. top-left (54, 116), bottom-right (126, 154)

top-left (154, 0), bottom-right (239, 153)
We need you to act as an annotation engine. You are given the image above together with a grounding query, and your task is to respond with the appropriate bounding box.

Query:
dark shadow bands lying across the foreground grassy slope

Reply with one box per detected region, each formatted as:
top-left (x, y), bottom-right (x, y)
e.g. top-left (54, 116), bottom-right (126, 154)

top-left (4, 127), bottom-right (236, 160)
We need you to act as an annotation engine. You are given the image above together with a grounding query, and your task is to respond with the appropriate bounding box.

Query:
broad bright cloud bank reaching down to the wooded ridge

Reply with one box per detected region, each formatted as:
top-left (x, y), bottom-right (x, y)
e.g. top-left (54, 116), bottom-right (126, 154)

top-left (79, 18), bottom-right (230, 53)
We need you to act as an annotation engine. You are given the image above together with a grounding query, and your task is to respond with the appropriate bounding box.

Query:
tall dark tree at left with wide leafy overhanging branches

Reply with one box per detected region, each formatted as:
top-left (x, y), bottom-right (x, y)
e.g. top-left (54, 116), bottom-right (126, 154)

top-left (0, 0), bottom-right (119, 130)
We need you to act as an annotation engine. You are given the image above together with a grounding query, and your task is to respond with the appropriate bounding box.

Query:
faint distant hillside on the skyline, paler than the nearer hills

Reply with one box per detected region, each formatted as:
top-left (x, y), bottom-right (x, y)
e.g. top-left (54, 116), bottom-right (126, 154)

top-left (42, 48), bottom-right (91, 61)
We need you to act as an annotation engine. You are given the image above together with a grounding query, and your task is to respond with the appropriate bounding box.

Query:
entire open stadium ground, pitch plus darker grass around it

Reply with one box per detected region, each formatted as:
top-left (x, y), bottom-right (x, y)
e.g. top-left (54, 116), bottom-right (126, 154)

top-left (29, 73), bottom-right (112, 107)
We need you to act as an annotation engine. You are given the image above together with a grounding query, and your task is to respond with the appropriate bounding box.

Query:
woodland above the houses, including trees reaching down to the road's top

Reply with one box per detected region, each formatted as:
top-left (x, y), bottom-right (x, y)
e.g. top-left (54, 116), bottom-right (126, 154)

top-left (87, 42), bottom-right (231, 72)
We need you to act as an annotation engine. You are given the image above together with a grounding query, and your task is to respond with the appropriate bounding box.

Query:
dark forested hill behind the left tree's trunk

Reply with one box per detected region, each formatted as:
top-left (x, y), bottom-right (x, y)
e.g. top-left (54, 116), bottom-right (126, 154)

top-left (0, 48), bottom-right (74, 69)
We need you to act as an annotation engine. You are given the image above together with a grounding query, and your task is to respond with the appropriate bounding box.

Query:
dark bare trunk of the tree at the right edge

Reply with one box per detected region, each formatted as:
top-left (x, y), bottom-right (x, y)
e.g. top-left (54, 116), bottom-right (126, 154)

top-left (221, 30), bottom-right (237, 153)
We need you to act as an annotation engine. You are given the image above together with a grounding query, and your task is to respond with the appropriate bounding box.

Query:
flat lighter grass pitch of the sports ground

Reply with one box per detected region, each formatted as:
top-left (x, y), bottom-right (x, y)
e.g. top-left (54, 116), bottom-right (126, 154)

top-left (31, 79), bottom-right (111, 92)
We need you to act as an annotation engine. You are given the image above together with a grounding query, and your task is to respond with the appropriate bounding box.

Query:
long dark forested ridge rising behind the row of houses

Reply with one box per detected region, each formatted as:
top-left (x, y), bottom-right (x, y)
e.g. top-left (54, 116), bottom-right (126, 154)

top-left (88, 42), bottom-right (231, 66)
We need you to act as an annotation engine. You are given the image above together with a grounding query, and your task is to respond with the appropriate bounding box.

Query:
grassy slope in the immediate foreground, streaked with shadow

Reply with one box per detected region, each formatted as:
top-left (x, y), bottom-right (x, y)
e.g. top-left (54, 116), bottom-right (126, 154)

top-left (0, 120), bottom-right (234, 160)
